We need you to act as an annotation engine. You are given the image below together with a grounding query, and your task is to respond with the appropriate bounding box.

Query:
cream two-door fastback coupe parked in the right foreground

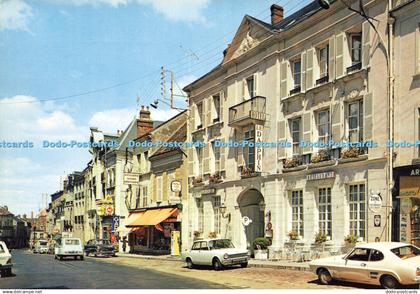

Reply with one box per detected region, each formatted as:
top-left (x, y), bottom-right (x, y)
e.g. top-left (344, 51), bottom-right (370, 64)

top-left (309, 242), bottom-right (420, 289)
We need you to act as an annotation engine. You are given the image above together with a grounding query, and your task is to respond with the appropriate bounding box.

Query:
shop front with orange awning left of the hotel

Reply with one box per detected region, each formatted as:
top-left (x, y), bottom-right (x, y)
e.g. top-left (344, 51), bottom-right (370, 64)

top-left (126, 207), bottom-right (181, 255)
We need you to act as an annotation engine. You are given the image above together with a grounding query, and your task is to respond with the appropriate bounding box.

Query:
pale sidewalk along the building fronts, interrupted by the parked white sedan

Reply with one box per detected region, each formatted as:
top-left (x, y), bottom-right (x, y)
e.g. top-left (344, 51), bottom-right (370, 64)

top-left (117, 252), bottom-right (309, 271)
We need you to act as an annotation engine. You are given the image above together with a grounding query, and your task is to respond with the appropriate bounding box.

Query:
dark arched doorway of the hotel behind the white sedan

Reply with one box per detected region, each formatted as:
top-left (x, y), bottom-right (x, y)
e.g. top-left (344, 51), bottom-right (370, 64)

top-left (238, 189), bottom-right (265, 251)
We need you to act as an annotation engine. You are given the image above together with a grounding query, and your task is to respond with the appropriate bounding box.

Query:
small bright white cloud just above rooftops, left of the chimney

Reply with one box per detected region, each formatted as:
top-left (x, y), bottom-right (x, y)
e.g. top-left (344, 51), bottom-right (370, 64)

top-left (89, 108), bottom-right (135, 133)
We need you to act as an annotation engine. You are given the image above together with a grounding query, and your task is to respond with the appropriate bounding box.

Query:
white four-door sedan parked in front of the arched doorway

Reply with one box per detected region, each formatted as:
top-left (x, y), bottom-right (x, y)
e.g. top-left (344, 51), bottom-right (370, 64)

top-left (182, 239), bottom-right (249, 270)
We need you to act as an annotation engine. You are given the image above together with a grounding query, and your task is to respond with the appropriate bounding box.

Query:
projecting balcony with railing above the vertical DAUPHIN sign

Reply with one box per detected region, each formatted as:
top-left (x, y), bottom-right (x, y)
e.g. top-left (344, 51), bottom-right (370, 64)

top-left (229, 96), bottom-right (267, 127)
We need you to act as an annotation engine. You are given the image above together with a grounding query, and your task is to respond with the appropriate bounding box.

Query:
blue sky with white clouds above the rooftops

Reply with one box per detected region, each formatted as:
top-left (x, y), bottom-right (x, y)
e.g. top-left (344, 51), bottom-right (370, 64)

top-left (0, 0), bottom-right (310, 214)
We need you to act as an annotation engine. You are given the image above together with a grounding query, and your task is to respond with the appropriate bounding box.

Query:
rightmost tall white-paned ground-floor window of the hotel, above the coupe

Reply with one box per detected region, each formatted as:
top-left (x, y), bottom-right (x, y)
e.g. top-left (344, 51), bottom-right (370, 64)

top-left (349, 184), bottom-right (366, 239)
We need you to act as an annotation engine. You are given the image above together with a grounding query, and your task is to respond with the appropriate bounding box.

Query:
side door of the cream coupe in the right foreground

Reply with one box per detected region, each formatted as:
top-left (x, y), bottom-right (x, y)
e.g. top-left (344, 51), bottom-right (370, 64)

top-left (339, 248), bottom-right (371, 283)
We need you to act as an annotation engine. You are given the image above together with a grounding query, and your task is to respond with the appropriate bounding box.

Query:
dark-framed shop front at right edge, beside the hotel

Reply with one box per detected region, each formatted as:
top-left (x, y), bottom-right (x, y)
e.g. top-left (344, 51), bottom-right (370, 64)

top-left (393, 165), bottom-right (420, 246)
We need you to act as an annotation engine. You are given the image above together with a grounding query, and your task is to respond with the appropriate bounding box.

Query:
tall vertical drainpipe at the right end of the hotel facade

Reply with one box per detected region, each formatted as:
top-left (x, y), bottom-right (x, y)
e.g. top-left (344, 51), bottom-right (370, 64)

top-left (386, 0), bottom-right (395, 241)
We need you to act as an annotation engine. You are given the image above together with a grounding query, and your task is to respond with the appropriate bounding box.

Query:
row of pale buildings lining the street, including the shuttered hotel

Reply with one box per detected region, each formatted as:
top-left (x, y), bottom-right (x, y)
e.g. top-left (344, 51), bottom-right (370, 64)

top-left (48, 0), bottom-right (420, 254)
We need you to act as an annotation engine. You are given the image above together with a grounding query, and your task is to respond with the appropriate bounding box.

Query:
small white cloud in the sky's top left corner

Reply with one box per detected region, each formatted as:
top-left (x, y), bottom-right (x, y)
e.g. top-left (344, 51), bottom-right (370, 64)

top-left (0, 0), bottom-right (33, 32)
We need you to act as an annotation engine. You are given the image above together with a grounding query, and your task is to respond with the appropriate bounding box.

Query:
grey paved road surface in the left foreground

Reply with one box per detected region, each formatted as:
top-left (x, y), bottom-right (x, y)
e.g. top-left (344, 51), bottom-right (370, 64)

top-left (0, 250), bottom-right (225, 289)
